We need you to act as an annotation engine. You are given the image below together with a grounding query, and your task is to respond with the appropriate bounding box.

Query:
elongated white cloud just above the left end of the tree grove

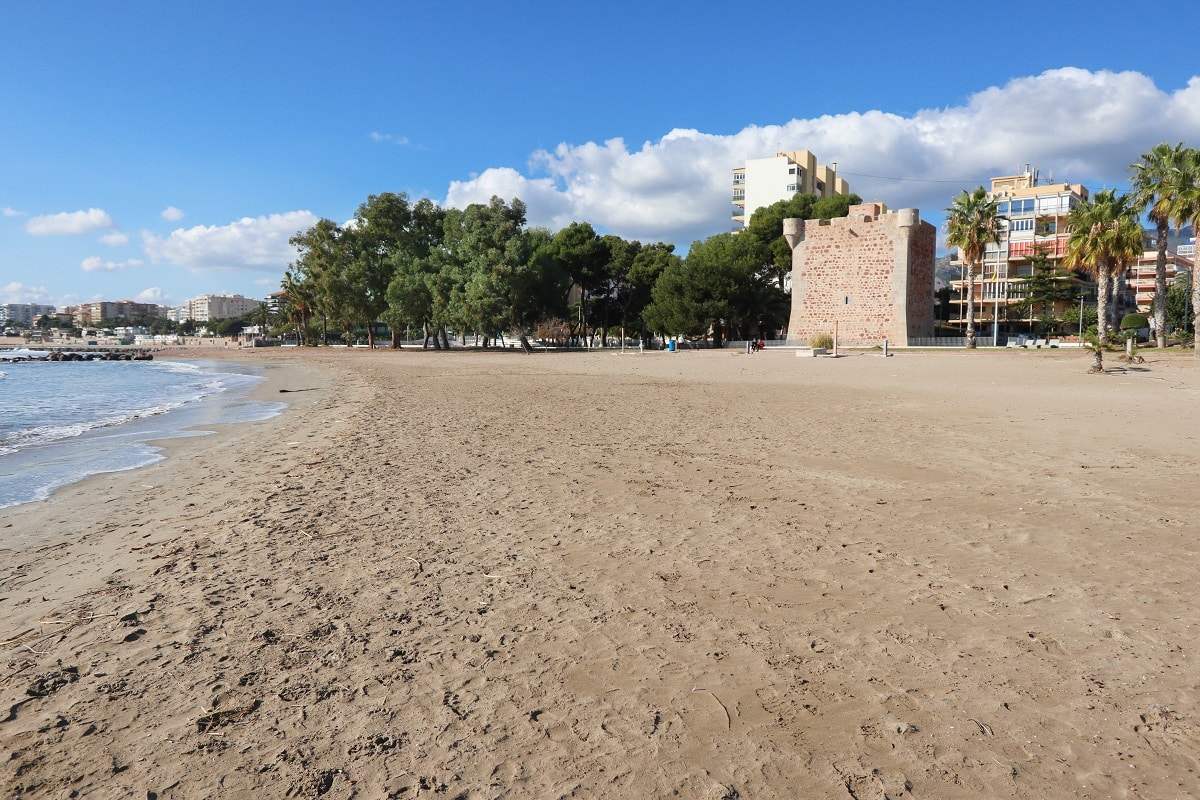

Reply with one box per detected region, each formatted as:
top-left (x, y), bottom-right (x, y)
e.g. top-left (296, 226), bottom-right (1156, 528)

top-left (142, 211), bottom-right (317, 272)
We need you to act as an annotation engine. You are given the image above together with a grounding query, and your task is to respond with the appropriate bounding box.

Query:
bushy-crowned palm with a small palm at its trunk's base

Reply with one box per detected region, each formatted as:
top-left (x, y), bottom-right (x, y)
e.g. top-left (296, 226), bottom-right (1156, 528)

top-left (1063, 190), bottom-right (1144, 372)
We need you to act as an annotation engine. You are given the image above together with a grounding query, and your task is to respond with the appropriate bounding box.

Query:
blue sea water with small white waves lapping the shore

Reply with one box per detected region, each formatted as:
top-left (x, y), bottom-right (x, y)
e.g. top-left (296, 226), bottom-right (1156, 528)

top-left (0, 351), bottom-right (284, 509)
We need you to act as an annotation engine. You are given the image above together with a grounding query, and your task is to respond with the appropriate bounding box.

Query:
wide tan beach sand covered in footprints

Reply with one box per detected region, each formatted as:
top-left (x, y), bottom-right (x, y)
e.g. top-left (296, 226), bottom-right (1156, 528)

top-left (0, 350), bottom-right (1200, 800)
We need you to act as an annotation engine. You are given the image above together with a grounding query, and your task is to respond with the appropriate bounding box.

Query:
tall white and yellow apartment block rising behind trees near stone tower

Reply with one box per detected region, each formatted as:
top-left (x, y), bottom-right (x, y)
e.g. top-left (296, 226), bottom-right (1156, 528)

top-left (733, 150), bottom-right (850, 230)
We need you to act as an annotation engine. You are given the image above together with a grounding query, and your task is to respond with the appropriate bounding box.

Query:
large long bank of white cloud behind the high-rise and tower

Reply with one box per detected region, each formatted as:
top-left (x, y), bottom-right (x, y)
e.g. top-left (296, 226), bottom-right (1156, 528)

top-left (445, 67), bottom-right (1200, 247)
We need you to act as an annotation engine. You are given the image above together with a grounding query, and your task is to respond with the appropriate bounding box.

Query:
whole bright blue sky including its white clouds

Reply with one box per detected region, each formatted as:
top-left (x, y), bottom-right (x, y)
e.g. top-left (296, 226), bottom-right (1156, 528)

top-left (0, 0), bottom-right (1200, 306)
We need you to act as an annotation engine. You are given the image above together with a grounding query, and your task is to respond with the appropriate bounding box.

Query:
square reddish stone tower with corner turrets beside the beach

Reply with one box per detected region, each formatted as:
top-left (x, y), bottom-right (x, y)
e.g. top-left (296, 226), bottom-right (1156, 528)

top-left (784, 203), bottom-right (937, 347)
